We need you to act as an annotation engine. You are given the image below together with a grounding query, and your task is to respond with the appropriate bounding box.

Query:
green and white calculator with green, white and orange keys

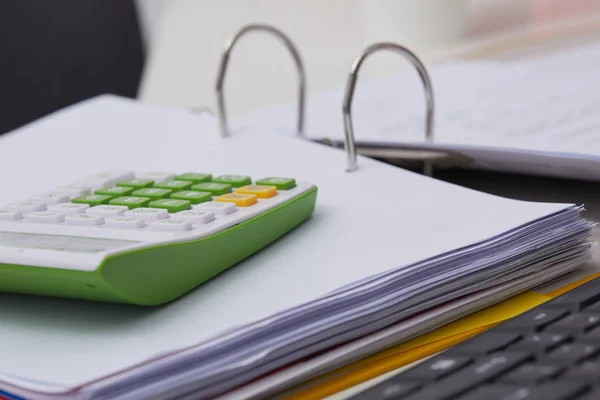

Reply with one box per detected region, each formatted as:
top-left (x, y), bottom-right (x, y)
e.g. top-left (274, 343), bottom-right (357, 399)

top-left (0, 171), bottom-right (317, 306)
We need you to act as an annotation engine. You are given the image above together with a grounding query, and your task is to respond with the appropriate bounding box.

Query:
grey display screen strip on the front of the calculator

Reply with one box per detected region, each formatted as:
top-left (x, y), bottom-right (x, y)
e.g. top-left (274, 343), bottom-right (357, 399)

top-left (0, 231), bottom-right (139, 253)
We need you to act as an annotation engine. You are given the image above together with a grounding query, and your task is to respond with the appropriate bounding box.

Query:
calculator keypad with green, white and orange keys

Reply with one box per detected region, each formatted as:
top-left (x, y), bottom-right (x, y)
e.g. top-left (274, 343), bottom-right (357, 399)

top-left (0, 171), bottom-right (312, 252)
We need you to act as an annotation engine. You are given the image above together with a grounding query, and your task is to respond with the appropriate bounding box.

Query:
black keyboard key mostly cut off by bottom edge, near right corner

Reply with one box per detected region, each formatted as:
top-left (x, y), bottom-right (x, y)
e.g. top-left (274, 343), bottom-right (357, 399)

top-left (460, 382), bottom-right (586, 400)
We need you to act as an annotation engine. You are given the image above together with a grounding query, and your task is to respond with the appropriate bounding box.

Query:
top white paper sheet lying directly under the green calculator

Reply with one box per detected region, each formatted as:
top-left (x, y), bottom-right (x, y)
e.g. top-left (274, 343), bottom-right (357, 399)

top-left (0, 96), bottom-right (580, 387)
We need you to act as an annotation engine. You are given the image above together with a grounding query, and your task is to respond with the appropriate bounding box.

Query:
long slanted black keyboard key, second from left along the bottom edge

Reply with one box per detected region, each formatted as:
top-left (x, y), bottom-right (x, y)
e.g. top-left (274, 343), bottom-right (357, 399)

top-left (408, 353), bottom-right (532, 400)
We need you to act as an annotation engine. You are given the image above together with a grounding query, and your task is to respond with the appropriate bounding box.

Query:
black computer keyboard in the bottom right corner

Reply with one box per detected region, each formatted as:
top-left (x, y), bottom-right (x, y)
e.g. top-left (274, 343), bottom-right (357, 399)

top-left (351, 278), bottom-right (600, 400)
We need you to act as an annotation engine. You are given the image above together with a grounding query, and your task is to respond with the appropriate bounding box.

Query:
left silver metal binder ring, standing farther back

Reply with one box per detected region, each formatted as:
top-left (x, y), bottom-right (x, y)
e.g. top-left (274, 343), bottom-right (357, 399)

top-left (216, 24), bottom-right (306, 137)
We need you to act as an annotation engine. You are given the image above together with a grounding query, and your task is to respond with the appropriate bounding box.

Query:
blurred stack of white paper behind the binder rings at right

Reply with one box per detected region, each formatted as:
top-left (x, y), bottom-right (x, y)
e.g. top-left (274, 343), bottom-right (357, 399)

top-left (249, 39), bottom-right (600, 181)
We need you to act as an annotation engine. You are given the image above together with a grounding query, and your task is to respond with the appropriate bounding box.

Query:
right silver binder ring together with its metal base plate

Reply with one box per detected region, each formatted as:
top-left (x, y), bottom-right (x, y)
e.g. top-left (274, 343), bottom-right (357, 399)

top-left (340, 42), bottom-right (468, 176)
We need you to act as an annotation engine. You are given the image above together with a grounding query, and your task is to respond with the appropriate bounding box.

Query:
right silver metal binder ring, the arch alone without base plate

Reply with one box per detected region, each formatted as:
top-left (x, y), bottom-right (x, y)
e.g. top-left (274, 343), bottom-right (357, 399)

top-left (343, 42), bottom-right (434, 176)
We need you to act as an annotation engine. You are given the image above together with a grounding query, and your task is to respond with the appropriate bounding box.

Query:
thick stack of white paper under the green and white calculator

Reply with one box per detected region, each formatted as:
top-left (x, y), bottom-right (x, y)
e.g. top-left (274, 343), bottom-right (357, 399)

top-left (0, 97), bottom-right (591, 399)
